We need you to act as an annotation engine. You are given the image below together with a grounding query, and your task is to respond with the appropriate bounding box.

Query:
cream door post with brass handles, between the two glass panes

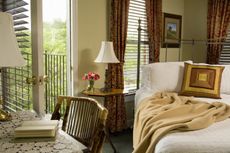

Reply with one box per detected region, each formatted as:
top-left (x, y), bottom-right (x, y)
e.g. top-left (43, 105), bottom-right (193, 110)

top-left (30, 0), bottom-right (45, 116)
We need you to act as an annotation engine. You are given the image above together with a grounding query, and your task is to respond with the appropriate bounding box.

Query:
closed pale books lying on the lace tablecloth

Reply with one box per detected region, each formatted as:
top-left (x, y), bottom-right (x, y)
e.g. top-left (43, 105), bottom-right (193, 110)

top-left (14, 120), bottom-right (58, 138)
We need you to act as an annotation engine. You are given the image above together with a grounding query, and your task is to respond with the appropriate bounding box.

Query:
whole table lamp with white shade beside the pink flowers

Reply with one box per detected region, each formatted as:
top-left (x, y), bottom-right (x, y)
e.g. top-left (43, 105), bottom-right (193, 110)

top-left (94, 41), bottom-right (119, 92)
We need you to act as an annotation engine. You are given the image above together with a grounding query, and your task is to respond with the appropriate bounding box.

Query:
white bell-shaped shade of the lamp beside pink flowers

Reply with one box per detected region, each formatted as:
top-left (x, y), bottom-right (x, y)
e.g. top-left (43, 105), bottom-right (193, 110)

top-left (94, 41), bottom-right (119, 63)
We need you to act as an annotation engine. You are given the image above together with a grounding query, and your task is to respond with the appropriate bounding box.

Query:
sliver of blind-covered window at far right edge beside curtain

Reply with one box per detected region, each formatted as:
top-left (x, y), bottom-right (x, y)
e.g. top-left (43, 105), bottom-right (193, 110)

top-left (219, 27), bottom-right (230, 64)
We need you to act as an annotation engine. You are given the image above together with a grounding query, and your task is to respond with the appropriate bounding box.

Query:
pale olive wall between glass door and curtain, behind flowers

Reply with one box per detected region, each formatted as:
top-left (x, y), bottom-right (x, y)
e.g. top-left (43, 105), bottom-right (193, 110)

top-left (74, 0), bottom-right (108, 95)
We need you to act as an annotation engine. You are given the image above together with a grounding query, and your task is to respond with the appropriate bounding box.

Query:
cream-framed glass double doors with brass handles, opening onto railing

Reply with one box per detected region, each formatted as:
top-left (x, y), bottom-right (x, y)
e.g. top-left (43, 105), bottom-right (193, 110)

top-left (0, 0), bottom-right (71, 115)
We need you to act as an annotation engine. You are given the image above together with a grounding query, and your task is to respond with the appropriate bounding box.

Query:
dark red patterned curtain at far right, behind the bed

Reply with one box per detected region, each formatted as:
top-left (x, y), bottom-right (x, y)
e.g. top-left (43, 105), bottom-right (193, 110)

top-left (207, 0), bottom-right (230, 64)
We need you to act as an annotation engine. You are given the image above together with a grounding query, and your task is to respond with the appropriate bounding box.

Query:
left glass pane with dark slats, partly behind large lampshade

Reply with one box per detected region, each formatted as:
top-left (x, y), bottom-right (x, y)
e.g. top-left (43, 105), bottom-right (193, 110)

top-left (0, 0), bottom-right (32, 111)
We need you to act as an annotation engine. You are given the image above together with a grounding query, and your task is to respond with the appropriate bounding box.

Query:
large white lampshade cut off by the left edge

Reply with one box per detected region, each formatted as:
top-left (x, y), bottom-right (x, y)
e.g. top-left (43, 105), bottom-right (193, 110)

top-left (0, 12), bottom-right (26, 67)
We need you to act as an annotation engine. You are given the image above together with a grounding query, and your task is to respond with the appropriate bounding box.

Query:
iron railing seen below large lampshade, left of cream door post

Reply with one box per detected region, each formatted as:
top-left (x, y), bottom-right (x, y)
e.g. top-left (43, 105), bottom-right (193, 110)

top-left (1, 53), bottom-right (33, 112)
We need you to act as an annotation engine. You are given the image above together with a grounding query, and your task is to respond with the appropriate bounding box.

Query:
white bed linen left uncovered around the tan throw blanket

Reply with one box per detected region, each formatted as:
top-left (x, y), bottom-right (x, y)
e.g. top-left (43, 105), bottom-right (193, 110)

top-left (135, 88), bottom-right (230, 153)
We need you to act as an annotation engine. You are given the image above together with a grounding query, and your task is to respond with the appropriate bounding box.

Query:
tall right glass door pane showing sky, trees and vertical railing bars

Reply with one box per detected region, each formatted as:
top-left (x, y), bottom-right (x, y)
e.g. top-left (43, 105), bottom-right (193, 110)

top-left (43, 0), bottom-right (70, 113)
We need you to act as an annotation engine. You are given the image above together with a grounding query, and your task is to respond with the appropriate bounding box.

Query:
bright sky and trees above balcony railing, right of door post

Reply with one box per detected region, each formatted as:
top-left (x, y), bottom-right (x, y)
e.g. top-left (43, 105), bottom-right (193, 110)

top-left (43, 0), bottom-right (67, 54)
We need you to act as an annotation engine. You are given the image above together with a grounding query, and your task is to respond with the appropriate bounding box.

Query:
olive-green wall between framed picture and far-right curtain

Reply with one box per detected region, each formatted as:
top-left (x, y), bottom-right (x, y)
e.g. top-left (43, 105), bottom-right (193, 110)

top-left (183, 0), bottom-right (208, 62)
